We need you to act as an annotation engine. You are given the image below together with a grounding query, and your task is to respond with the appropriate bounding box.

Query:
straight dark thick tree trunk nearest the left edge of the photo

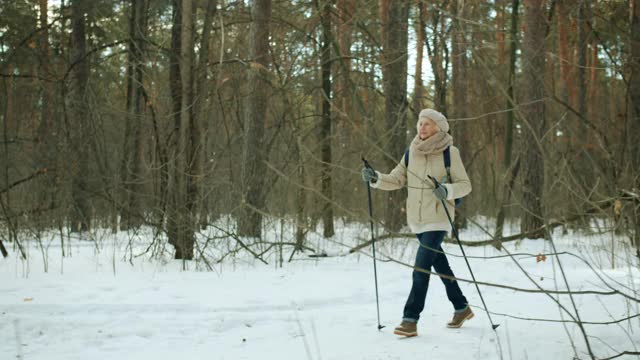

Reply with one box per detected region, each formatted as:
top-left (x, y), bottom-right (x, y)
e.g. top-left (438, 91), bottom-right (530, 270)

top-left (66, 0), bottom-right (91, 232)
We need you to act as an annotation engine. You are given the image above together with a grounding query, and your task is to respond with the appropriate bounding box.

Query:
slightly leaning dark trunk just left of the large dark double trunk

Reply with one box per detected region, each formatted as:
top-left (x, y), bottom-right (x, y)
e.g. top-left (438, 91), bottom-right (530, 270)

top-left (120, 0), bottom-right (147, 230)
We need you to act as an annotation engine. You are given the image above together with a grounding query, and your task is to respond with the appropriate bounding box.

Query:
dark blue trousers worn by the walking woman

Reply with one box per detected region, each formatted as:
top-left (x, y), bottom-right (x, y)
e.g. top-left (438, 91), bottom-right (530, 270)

top-left (403, 231), bottom-right (467, 322)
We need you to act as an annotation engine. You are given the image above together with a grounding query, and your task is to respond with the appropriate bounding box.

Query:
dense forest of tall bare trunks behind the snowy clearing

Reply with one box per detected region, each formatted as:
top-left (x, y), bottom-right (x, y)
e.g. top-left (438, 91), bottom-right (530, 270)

top-left (0, 0), bottom-right (640, 260)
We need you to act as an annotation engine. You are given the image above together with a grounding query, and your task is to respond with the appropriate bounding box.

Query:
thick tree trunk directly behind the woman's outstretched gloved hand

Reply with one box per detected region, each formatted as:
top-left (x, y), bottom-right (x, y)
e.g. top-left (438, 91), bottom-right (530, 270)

top-left (382, 1), bottom-right (409, 231)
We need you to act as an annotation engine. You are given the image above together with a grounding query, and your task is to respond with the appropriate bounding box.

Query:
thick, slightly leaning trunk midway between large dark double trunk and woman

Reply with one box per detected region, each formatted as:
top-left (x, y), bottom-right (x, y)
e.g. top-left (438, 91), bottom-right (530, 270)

top-left (238, 0), bottom-right (271, 237)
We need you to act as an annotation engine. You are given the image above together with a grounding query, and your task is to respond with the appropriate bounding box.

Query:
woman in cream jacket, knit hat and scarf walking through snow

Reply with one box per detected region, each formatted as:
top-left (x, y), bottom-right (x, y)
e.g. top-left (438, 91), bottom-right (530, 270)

top-left (362, 109), bottom-right (473, 337)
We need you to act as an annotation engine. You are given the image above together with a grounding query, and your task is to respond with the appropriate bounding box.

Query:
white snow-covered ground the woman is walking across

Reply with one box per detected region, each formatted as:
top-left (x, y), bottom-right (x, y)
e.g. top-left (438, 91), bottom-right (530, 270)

top-left (0, 218), bottom-right (640, 360)
